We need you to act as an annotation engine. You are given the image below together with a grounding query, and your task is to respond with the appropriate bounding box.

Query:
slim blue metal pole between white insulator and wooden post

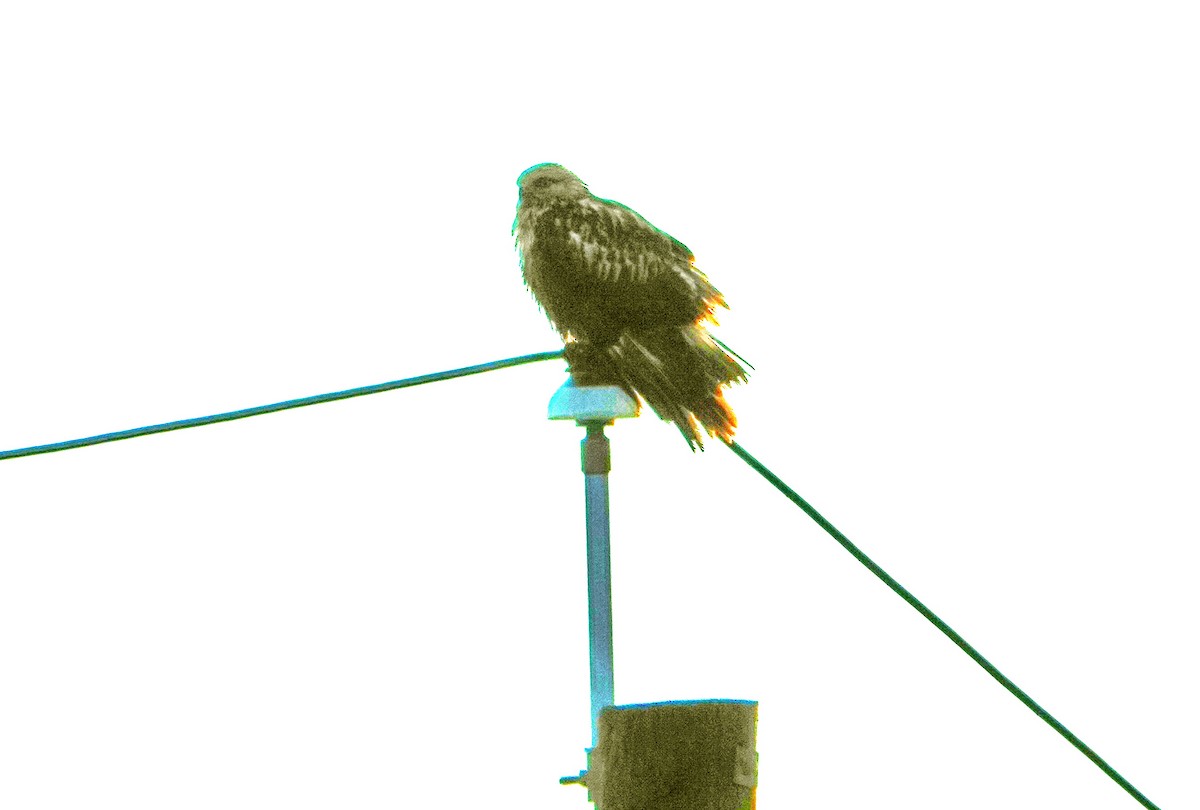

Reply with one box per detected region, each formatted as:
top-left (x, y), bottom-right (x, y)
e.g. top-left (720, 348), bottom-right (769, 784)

top-left (582, 421), bottom-right (614, 748)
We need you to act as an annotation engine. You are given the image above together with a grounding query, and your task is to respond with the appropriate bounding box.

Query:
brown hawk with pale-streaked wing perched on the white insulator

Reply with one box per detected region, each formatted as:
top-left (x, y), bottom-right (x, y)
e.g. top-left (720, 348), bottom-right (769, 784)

top-left (512, 163), bottom-right (746, 450)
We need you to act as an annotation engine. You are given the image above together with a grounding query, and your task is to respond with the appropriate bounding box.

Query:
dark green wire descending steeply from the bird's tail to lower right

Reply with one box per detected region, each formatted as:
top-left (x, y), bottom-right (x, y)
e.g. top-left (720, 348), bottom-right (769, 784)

top-left (726, 439), bottom-right (1159, 810)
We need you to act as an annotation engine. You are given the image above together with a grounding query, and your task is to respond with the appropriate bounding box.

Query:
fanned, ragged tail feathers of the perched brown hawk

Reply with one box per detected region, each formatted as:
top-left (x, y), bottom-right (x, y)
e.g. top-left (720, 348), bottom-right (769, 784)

top-left (605, 324), bottom-right (749, 450)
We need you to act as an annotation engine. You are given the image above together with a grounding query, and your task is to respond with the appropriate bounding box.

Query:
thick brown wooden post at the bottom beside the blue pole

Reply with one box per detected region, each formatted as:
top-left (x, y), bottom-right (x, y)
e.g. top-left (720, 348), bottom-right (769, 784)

top-left (582, 701), bottom-right (758, 810)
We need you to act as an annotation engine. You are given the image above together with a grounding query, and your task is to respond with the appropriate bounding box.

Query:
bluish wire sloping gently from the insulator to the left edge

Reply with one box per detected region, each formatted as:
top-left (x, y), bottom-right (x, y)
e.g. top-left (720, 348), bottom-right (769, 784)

top-left (0, 350), bottom-right (563, 461)
